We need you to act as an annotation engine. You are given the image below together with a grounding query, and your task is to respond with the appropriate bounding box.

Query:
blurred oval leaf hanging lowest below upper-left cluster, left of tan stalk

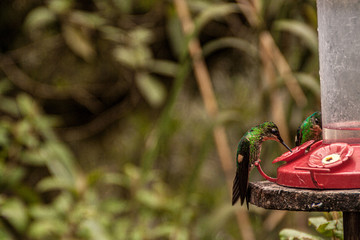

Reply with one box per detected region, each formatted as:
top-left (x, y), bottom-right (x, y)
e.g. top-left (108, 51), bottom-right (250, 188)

top-left (136, 73), bottom-right (166, 107)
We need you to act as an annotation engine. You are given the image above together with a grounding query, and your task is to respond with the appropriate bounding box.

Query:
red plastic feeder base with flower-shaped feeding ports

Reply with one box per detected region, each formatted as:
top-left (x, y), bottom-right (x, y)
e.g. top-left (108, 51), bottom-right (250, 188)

top-left (257, 141), bottom-right (360, 189)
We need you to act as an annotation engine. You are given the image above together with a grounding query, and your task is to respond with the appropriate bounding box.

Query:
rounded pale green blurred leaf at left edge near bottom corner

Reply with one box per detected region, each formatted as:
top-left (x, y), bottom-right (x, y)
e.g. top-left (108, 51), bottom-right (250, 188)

top-left (0, 198), bottom-right (29, 232)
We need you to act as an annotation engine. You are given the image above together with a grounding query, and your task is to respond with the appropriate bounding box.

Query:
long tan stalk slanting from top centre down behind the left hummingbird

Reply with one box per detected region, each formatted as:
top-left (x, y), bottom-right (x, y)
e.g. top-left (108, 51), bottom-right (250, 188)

top-left (174, 0), bottom-right (255, 240)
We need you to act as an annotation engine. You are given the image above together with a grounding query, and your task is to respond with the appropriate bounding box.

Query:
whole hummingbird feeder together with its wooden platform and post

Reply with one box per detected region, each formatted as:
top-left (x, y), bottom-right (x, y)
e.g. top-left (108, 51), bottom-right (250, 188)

top-left (249, 0), bottom-right (360, 240)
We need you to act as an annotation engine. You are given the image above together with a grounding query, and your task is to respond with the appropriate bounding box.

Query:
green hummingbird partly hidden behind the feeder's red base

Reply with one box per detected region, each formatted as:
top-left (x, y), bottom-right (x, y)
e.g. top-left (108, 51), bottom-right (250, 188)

top-left (295, 112), bottom-right (322, 146)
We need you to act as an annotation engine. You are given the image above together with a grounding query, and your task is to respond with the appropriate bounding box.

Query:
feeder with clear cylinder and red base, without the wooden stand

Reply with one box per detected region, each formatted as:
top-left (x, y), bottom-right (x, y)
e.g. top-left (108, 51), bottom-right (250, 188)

top-left (253, 0), bottom-right (360, 189)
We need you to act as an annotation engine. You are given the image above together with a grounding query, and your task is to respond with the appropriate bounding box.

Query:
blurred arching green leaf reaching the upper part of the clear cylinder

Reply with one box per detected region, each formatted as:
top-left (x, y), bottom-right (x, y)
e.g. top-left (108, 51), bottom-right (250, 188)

top-left (274, 20), bottom-right (318, 53)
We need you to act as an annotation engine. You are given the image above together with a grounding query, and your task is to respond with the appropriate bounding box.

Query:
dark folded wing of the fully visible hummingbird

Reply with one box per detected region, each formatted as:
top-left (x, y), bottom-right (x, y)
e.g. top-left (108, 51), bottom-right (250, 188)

top-left (232, 139), bottom-right (250, 205)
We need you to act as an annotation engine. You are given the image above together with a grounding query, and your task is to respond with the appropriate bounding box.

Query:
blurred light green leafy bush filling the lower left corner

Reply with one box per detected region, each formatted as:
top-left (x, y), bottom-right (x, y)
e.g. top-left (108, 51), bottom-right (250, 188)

top-left (0, 90), bottom-right (199, 239)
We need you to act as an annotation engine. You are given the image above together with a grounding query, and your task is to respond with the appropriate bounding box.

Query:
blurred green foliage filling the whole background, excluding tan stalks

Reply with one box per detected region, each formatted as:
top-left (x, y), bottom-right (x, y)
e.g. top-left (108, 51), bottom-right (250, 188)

top-left (0, 0), bottom-right (320, 240)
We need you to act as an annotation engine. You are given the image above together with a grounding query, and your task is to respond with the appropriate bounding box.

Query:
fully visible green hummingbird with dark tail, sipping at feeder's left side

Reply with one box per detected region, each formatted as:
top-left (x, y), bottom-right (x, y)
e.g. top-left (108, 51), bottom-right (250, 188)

top-left (232, 122), bottom-right (291, 208)
